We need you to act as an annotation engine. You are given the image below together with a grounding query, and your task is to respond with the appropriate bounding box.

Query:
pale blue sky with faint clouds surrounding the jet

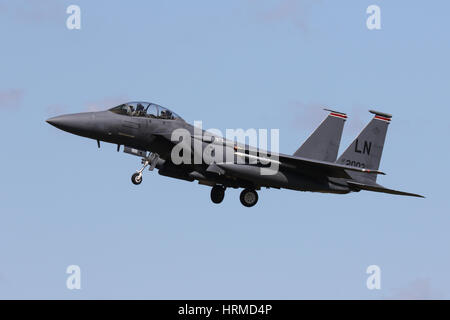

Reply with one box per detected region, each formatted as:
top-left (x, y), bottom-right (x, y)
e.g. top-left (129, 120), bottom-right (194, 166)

top-left (0, 0), bottom-right (450, 299)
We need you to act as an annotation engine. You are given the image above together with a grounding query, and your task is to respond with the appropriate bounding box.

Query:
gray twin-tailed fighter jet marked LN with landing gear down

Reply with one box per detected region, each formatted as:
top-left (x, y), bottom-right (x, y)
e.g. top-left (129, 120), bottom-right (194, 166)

top-left (47, 102), bottom-right (423, 207)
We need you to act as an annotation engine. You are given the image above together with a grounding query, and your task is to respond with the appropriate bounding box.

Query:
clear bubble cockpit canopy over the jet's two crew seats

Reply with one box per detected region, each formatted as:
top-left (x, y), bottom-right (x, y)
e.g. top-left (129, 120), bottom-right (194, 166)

top-left (109, 101), bottom-right (181, 120)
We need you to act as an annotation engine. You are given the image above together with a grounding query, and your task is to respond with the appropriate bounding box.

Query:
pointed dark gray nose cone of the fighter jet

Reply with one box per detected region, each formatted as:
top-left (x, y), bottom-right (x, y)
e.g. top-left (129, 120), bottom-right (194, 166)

top-left (46, 112), bottom-right (93, 135)
